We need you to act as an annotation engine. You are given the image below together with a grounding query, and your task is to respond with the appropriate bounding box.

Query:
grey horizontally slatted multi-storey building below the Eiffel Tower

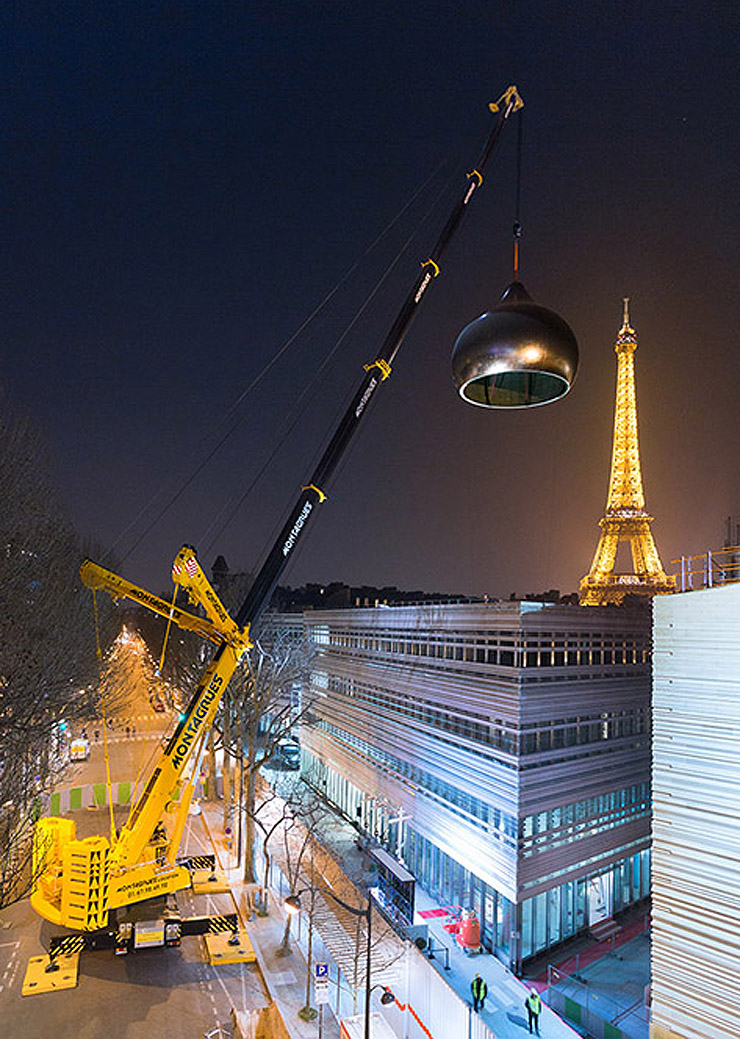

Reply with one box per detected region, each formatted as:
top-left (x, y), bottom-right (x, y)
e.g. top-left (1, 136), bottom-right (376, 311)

top-left (301, 602), bottom-right (652, 970)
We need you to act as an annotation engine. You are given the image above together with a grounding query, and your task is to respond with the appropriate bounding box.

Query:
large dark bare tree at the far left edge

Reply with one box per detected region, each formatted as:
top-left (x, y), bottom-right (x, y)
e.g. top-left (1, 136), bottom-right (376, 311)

top-left (0, 400), bottom-right (109, 907)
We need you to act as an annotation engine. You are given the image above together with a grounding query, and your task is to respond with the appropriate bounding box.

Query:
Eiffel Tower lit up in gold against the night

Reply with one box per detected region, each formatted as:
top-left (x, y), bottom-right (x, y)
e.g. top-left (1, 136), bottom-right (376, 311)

top-left (580, 298), bottom-right (676, 606)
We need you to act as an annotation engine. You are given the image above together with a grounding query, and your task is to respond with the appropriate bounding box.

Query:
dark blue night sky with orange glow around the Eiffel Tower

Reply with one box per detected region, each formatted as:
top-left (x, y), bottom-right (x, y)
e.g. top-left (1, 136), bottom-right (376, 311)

top-left (0, 6), bottom-right (740, 597)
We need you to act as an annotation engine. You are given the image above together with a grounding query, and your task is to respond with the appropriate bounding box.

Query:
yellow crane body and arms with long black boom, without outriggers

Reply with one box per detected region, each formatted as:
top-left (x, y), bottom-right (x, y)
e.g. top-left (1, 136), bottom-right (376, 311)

top-left (31, 86), bottom-right (523, 932)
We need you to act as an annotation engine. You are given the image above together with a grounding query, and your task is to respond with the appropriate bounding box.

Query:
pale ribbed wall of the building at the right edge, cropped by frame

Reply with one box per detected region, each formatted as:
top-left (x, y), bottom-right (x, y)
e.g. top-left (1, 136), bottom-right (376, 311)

top-left (651, 584), bottom-right (740, 1039)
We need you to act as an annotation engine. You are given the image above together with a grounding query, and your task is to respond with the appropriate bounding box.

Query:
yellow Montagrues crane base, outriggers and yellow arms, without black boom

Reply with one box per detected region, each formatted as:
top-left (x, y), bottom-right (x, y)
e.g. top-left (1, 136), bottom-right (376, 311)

top-left (31, 545), bottom-right (252, 960)
